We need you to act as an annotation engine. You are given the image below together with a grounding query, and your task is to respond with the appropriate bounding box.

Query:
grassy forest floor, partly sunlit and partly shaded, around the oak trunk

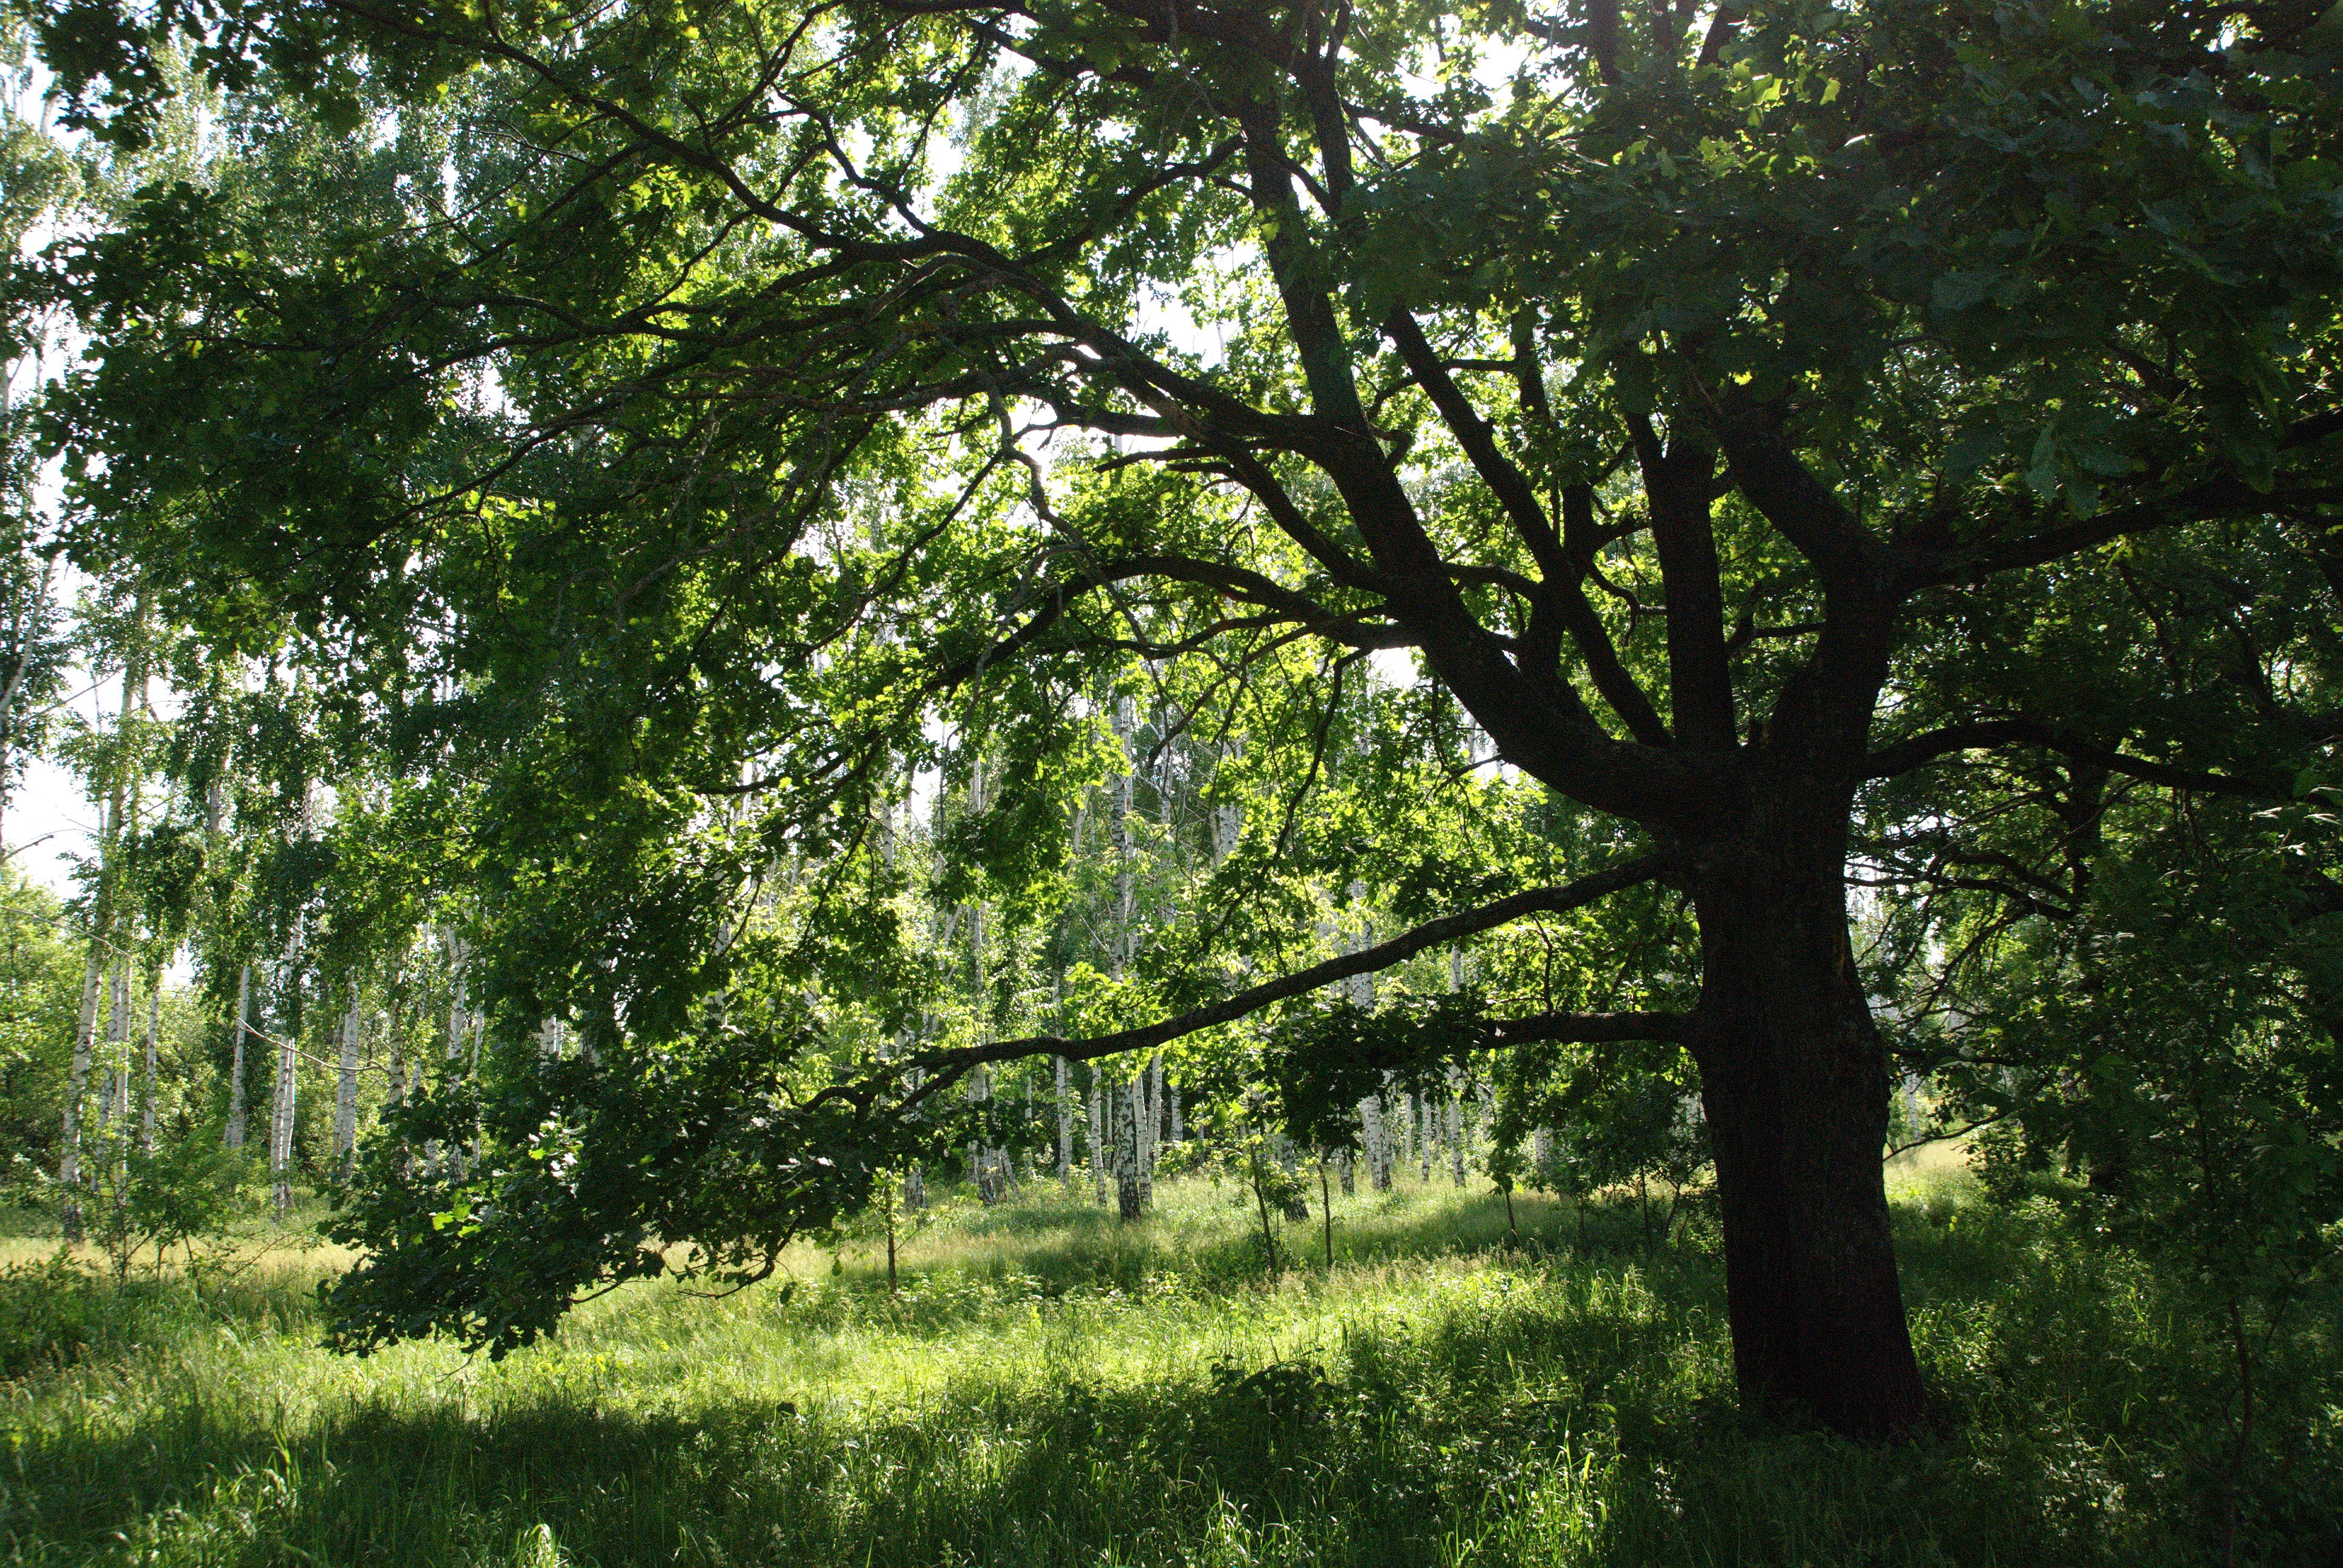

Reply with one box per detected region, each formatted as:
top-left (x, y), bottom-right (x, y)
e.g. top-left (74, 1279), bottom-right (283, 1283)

top-left (0, 1165), bottom-right (2343, 1568)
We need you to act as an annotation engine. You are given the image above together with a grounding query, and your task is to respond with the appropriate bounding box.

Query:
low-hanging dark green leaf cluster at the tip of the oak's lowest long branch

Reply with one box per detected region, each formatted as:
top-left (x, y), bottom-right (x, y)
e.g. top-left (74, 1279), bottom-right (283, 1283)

top-left (321, 1027), bottom-right (956, 1357)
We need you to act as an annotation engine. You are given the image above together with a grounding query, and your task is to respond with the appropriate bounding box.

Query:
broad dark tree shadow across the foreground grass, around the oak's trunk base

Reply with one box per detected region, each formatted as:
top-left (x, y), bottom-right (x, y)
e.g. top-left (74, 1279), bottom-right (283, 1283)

top-left (0, 1181), bottom-right (2334, 1568)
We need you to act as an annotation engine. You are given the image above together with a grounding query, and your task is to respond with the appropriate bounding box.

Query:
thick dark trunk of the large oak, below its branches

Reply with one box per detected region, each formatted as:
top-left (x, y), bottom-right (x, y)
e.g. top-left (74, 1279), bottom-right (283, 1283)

top-left (1694, 787), bottom-right (1926, 1434)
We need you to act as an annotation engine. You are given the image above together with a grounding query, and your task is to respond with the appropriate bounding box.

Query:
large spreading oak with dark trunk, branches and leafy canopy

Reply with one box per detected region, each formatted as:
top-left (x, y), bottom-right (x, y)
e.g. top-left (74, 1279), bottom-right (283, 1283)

top-left (22, 0), bottom-right (2343, 1432)
